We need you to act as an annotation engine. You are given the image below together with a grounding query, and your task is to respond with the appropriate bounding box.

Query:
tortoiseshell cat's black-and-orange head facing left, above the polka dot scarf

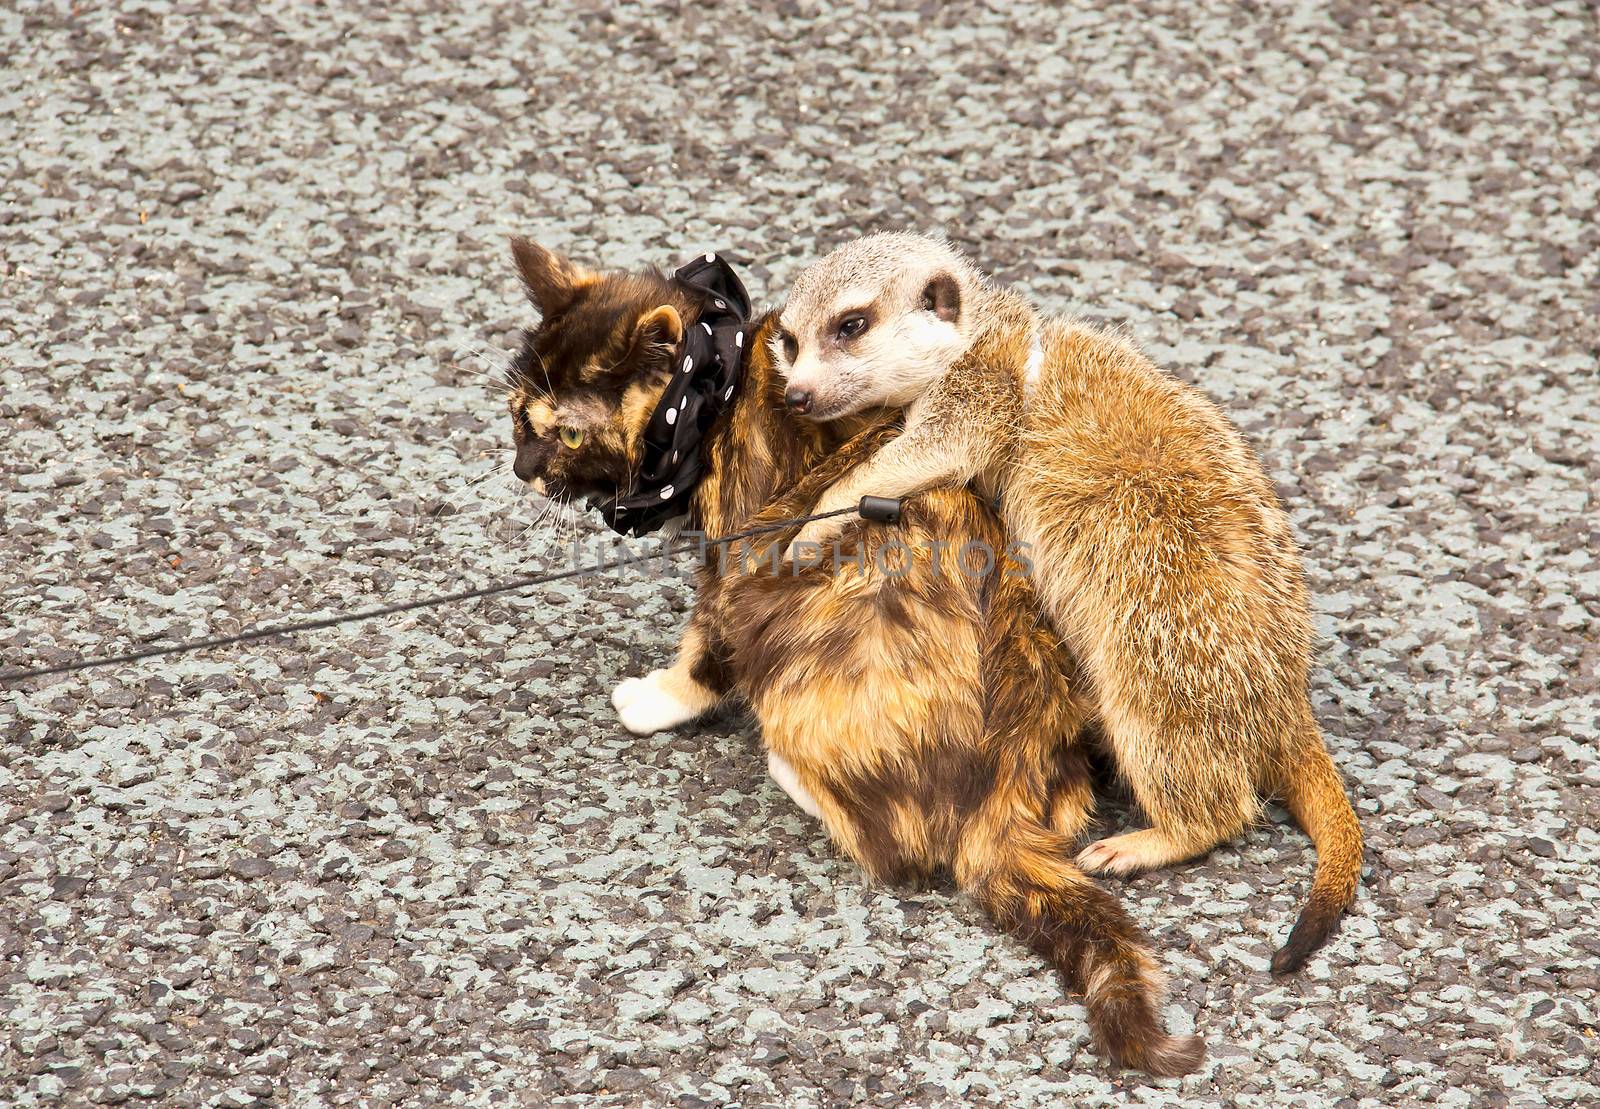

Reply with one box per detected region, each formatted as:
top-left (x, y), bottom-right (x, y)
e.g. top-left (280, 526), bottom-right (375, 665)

top-left (510, 238), bottom-right (694, 499)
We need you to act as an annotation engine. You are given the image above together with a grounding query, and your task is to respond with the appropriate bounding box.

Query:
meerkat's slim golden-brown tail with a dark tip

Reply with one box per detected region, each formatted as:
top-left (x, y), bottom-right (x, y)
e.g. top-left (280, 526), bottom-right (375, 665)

top-left (1272, 725), bottom-right (1362, 975)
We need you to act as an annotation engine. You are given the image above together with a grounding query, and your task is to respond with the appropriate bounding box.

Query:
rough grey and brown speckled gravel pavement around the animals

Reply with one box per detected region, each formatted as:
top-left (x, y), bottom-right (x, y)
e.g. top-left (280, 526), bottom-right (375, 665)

top-left (0, 0), bottom-right (1600, 1106)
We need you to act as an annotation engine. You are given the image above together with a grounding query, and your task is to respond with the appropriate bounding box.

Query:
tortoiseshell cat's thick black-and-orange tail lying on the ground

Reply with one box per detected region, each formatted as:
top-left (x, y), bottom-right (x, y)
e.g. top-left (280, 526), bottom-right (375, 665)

top-left (957, 821), bottom-right (1205, 1075)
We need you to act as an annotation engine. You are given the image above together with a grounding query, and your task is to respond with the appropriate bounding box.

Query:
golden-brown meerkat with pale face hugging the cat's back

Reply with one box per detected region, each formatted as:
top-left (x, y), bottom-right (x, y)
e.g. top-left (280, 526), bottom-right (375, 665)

top-left (771, 234), bottom-right (1362, 973)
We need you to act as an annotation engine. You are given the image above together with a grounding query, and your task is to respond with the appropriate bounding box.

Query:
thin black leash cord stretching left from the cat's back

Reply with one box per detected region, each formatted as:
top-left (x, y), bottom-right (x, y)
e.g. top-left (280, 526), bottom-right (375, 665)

top-left (0, 498), bottom-right (899, 685)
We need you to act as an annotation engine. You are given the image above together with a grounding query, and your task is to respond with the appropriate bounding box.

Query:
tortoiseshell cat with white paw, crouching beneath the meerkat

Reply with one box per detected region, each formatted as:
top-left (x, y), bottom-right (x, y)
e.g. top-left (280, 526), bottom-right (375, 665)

top-left (510, 240), bottom-right (1203, 1074)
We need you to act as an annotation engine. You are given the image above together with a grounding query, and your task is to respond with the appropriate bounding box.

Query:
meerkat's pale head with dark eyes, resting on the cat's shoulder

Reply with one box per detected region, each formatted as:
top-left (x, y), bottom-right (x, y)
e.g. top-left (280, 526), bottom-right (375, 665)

top-left (773, 232), bottom-right (984, 421)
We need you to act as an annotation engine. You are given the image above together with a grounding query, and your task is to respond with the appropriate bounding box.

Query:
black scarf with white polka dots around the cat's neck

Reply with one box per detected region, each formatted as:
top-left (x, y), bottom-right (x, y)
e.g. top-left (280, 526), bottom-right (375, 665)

top-left (600, 254), bottom-right (750, 536)
